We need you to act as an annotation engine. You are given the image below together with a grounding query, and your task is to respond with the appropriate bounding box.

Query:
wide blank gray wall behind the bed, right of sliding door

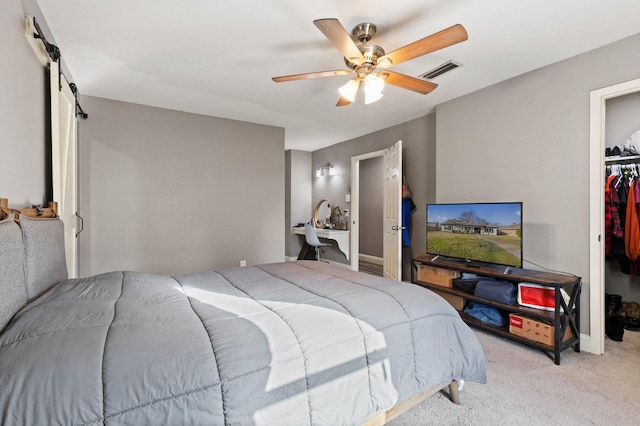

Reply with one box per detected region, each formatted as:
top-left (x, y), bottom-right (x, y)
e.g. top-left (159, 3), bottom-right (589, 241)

top-left (79, 96), bottom-right (285, 276)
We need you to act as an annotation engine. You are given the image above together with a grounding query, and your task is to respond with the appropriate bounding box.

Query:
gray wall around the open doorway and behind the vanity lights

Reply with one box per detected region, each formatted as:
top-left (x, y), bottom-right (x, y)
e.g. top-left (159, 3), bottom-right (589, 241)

top-left (312, 114), bottom-right (436, 263)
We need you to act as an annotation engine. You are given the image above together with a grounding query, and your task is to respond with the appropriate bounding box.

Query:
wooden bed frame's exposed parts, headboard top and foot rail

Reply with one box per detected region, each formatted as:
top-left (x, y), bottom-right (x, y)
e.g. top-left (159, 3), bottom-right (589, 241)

top-left (0, 198), bottom-right (460, 426)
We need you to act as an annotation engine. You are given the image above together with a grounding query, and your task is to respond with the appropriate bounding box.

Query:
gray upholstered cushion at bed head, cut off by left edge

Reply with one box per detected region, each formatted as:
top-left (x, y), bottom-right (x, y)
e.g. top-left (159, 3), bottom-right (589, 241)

top-left (0, 214), bottom-right (27, 331)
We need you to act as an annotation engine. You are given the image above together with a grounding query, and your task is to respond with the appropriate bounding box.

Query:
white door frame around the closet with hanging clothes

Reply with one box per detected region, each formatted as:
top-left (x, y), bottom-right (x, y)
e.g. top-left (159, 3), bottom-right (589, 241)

top-left (580, 78), bottom-right (640, 355)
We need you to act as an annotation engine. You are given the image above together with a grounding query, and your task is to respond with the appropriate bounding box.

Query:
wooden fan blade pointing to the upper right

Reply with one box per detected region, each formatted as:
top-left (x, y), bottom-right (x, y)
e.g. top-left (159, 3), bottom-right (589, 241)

top-left (378, 24), bottom-right (468, 67)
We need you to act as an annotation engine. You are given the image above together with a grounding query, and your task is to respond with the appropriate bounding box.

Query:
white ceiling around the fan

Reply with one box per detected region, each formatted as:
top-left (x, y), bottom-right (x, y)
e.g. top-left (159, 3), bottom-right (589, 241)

top-left (37, 0), bottom-right (640, 151)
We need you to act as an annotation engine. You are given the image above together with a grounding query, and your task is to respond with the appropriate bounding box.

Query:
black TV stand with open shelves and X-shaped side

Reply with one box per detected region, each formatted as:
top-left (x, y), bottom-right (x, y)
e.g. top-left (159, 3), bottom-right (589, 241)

top-left (412, 254), bottom-right (582, 365)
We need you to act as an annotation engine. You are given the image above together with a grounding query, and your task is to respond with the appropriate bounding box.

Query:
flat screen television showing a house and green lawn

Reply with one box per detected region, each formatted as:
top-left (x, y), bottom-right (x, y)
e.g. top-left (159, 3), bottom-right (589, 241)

top-left (427, 202), bottom-right (522, 268)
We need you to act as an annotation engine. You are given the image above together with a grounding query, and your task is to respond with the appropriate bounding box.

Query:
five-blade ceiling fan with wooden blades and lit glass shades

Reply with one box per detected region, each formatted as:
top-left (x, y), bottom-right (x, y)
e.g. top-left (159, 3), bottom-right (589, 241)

top-left (272, 18), bottom-right (467, 106)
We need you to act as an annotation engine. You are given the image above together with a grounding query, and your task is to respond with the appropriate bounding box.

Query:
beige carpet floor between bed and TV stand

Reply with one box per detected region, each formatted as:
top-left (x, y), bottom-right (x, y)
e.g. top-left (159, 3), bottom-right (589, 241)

top-left (389, 329), bottom-right (640, 426)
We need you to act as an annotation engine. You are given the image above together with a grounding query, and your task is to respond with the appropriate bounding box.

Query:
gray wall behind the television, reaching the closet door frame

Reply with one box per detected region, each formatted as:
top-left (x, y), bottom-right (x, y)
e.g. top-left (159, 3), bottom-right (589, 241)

top-left (436, 35), bottom-right (640, 331)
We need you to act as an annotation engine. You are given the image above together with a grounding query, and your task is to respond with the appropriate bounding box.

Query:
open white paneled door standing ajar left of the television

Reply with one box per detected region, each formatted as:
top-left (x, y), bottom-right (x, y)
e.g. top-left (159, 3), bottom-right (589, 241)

top-left (382, 141), bottom-right (402, 281)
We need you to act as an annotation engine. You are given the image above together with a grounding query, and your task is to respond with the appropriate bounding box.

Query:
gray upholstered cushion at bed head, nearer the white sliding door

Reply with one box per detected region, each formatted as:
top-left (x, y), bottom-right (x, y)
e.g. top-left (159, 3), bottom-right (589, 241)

top-left (20, 215), bottom-right (67, 300)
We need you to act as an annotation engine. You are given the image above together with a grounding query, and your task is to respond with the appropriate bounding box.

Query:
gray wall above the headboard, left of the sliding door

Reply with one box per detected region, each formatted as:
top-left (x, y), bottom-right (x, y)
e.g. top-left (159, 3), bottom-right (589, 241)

top-left (0, 0), bottom-right (50, 208)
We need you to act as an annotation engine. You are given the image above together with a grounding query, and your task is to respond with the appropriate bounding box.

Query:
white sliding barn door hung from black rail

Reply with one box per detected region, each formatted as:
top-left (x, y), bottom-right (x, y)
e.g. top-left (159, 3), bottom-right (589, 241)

top-left (49, 61), bottom-right (78, 278)
